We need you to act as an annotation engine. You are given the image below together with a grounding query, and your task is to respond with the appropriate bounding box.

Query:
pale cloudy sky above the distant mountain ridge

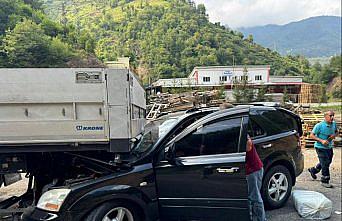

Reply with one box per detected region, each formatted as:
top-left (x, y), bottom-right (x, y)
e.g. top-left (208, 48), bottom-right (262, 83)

top-left (194, 0), bottom-right (341, 28)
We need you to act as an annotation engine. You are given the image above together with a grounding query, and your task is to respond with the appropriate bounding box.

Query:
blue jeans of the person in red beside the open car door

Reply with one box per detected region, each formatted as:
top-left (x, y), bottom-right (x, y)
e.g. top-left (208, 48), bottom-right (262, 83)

top-left (247, 168), bottom-right (266, 221)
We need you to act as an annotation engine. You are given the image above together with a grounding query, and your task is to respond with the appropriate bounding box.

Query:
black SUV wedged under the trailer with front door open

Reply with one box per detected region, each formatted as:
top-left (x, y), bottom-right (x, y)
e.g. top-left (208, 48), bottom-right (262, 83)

top-left (23, 106), bottom-right (303, 221)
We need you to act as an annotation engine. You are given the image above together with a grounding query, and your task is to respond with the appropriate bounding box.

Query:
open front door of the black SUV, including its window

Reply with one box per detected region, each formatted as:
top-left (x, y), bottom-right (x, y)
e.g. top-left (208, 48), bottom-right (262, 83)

top-left (155, 117), bottom-right (249, 221)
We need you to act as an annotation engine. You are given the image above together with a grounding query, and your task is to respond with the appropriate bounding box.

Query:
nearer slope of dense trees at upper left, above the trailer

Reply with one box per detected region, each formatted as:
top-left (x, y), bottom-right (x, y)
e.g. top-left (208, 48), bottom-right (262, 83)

top-left (0, 0), bottom-right (101, 67)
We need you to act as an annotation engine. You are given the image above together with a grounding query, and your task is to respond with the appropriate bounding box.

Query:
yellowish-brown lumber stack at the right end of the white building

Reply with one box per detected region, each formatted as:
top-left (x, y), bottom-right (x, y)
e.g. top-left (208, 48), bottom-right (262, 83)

top-left (299, 84), bottom-right (322, 104)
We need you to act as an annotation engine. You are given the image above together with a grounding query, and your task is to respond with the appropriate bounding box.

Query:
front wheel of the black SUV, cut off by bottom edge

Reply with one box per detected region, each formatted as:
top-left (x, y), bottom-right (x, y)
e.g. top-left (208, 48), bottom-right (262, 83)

top-left (85, 202), bottom-right (142, 221)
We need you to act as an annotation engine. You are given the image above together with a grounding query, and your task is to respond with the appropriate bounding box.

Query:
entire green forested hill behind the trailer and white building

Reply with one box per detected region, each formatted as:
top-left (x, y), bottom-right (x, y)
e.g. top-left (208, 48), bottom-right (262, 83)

top-left (0, 0), bottom-right (340, 89)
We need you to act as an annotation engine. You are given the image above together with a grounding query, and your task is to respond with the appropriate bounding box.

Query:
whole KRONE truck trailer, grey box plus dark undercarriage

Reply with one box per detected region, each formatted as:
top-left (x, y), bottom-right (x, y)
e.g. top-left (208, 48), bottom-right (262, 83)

top-left (0, 68), bottom-right (146, 218)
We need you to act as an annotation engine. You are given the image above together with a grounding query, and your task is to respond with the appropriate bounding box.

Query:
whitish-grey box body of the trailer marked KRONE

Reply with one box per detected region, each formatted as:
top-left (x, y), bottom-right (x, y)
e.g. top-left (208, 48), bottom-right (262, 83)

top-left (0, 68), bottom-right (145, 152)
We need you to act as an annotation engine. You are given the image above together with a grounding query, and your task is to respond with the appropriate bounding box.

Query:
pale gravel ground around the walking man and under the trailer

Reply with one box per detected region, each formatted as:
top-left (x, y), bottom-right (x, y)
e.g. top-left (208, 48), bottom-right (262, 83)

top-left (0, 148), bottom-right (341, 221)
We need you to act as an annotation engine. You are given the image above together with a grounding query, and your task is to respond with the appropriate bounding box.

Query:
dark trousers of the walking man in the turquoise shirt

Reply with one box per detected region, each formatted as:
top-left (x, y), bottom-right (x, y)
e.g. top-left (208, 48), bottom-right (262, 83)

top-left (312, 148), bottom-right (334, 183)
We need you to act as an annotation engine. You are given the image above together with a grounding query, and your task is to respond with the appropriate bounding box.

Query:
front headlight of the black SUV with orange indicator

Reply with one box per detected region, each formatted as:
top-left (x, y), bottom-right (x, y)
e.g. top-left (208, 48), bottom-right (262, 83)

top-left (37, 189), bottom-right (71, 212)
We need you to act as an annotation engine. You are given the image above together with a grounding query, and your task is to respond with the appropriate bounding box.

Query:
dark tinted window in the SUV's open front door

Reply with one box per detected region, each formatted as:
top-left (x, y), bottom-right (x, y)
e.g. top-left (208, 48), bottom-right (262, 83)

top-left (175, 118), bottom-right (241, 157)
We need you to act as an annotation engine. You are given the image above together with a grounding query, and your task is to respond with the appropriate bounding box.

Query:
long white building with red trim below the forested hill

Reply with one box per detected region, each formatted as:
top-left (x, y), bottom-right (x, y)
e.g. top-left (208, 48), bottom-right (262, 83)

top-left (148, 65), bottom-right (306, 102)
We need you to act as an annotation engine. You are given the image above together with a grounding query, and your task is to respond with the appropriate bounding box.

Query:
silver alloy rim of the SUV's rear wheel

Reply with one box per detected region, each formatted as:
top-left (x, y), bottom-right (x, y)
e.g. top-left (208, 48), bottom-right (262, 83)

top-left (268, 173), bottom-right (289, 202)
